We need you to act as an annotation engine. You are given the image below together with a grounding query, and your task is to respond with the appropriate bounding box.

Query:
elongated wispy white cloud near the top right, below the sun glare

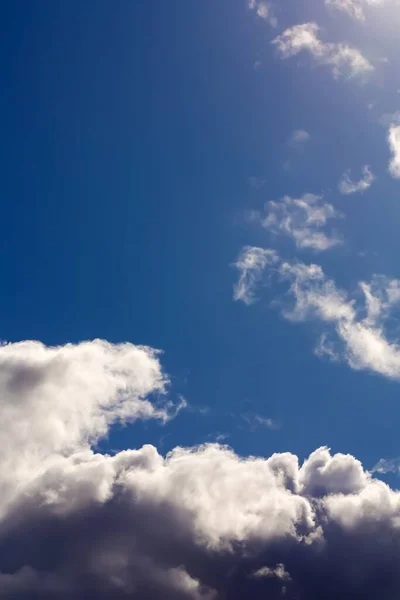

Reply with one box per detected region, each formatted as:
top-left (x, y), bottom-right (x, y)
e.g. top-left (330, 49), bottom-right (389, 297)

top-left (272, 23), bottom-right (373, 79)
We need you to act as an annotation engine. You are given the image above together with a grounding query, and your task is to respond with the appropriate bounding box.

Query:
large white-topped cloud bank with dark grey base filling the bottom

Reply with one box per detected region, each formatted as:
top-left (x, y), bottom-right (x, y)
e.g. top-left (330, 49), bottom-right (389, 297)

top-left (0, 341), bottom-right (400, 600)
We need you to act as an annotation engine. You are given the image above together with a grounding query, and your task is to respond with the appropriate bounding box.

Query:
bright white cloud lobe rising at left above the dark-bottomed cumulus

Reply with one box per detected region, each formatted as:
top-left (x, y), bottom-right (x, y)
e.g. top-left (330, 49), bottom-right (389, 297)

top-left (0, 340), bottom-right (184, 515)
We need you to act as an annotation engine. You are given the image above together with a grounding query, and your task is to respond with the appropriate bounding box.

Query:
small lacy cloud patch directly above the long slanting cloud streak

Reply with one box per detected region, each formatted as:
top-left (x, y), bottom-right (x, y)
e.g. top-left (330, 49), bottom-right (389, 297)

top-left (262, 194), bottom-right (342, 251)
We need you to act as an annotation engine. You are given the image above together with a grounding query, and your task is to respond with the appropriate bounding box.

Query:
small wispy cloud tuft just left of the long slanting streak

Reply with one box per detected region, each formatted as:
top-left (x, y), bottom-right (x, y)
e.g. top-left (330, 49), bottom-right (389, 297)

top-left (233, 246), bottom-right (278, 304)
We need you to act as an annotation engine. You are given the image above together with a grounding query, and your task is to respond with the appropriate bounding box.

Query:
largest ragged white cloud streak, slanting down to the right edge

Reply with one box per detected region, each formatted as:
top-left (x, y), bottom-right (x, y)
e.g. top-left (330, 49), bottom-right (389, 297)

top-left (234, 248), bottom-right (400, 380)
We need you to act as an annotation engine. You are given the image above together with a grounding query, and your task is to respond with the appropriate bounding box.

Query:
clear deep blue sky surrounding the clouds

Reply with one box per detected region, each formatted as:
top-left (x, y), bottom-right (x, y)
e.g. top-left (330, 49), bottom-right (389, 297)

top-left (0, 0), bottom-right (400, 474)
